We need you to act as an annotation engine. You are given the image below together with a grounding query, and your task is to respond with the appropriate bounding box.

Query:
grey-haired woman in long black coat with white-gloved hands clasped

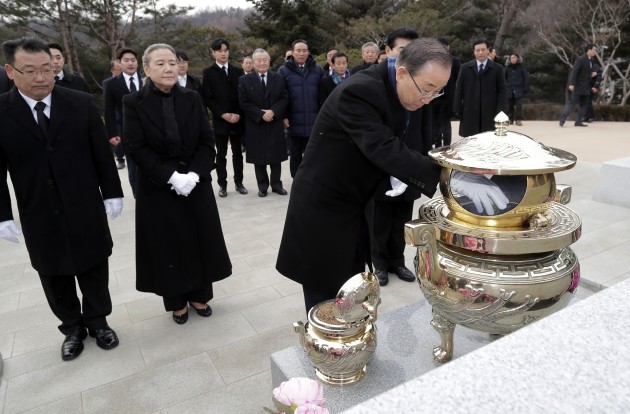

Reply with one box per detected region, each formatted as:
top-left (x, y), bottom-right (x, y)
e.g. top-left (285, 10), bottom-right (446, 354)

top-left (123, 44), bottom-right (232, 324)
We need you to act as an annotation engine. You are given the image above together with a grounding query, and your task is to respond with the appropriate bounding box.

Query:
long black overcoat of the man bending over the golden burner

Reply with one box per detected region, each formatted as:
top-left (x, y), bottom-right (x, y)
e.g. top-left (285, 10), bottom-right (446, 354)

top-left (276, 64), bottom-right (440, 291)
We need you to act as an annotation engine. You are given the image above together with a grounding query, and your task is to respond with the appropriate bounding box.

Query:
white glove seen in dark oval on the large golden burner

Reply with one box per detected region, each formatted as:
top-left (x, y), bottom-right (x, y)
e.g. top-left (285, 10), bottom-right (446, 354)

top-left (451, 171), bottom-right (510, 216)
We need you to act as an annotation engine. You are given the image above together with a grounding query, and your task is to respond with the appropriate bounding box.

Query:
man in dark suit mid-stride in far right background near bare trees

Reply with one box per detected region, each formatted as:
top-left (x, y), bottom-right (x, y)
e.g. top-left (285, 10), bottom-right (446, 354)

top-left (560, 43), bottom-right (597, 126)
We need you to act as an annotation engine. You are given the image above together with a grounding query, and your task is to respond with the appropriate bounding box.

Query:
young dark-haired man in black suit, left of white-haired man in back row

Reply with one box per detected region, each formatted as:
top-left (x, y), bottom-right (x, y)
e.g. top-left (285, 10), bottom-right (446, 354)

top-left (203, 38), bottom-right (247, 197)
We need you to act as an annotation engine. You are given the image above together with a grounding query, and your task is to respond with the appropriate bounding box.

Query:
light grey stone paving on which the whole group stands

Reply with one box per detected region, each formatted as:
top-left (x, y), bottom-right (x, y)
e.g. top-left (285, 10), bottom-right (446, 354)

top-left (0, 121), bottom-right (630, 414)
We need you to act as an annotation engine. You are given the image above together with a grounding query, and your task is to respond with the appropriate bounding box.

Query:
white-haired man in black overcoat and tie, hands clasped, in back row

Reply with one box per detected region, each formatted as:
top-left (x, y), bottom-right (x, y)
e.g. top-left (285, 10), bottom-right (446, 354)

top-left (238, 49), bottom-right (289, 197)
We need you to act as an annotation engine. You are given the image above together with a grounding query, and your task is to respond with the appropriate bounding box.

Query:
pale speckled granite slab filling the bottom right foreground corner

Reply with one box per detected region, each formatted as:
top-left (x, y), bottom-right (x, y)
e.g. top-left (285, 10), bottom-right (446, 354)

top-left (344, 280), bottom-right (630, 414)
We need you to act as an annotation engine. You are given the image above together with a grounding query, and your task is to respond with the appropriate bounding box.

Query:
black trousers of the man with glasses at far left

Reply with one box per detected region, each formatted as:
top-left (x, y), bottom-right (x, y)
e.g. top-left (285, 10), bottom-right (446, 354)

top-left (39, 259), bottom-right (112, 335)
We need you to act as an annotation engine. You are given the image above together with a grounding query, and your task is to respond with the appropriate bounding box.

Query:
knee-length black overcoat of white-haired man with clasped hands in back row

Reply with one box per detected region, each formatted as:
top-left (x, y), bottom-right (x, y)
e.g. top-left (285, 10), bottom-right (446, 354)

top-left (238, 71), bottom-right (289, 165)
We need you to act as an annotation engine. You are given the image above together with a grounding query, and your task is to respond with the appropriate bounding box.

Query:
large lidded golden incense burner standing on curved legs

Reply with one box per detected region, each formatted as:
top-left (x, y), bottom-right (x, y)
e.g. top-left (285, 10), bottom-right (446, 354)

top-left (405, 113), bottom-right (582, 362)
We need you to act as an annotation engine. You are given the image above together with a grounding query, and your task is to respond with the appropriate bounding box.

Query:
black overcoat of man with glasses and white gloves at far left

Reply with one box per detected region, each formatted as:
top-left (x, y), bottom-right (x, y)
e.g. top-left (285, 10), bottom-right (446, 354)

top-left (0, 86), bottom-right (123, 276)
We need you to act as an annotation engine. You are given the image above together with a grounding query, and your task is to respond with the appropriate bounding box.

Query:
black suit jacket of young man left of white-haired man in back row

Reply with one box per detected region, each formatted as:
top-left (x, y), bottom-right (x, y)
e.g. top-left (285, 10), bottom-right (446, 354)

top-left (202, 63), bottom-right (245, 135)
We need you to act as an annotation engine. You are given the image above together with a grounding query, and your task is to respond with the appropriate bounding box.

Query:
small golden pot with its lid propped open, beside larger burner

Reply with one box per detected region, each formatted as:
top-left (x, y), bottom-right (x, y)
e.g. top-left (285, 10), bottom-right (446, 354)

top-left (293, 272), bottom-right (381, 385)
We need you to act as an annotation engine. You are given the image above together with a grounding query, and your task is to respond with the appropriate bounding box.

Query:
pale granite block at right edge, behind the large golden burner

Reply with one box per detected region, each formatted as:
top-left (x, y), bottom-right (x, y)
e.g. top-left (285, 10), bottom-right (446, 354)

top-left (593, 157), bottom-right (630, 207)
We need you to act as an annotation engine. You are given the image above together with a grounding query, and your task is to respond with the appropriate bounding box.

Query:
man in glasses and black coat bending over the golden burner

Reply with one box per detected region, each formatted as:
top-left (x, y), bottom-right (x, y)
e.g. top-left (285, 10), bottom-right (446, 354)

top-left (276, 39), bottom-right (451, 311)
